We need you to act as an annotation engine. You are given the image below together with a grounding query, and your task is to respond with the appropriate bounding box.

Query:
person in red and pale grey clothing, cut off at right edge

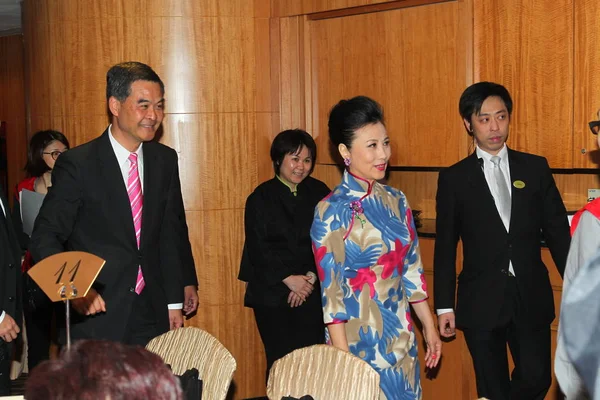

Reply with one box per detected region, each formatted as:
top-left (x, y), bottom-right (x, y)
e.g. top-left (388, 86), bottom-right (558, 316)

top-left (554, 111), bottom-right (600, 400)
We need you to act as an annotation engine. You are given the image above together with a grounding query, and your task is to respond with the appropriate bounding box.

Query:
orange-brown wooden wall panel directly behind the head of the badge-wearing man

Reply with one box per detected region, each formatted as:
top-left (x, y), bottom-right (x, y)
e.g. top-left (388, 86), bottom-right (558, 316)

top-left (474, 0), bottom-right (576, 168)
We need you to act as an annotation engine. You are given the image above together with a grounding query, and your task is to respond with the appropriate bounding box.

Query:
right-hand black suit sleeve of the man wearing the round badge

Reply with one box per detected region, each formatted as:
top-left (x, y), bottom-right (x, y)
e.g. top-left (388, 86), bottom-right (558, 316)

top-left (541, 159), bottom-right (571, 277)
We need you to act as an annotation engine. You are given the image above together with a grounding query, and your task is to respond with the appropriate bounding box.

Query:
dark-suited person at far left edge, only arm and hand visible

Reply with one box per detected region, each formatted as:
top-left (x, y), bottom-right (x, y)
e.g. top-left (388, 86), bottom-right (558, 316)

top-left (0, 186), bottom-right (21, 396)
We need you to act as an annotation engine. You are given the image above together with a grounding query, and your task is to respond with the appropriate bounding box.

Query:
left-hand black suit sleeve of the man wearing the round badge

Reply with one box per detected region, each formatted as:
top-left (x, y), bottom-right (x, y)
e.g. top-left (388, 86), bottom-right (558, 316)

top-left (433, 171), bottom-right (459, 309)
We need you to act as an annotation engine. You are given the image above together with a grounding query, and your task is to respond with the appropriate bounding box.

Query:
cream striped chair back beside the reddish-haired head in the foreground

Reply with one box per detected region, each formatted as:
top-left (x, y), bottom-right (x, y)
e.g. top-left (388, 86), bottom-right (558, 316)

top-left (146, 327), bottom-right (237, 400)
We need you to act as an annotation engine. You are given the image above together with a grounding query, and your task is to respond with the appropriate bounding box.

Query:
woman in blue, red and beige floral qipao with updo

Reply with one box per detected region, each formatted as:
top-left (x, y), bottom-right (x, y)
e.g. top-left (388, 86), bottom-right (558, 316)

top-left (311, 96), bottom-right (442, 400)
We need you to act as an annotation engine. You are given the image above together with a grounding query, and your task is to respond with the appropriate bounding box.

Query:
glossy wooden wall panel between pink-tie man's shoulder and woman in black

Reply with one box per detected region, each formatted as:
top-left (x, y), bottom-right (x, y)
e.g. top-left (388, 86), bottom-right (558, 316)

top-left (164, 113), bottom-right (258, 210)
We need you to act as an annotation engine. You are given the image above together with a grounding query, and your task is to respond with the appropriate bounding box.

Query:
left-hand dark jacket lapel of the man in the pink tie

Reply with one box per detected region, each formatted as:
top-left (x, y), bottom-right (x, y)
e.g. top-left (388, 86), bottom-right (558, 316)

top-left (97, 130), bottom-right (137, 248)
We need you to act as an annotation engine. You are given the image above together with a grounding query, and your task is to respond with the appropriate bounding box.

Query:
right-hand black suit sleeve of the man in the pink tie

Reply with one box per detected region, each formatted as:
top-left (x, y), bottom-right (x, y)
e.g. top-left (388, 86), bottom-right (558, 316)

top-left (159, 159), bottom-right (192, 304)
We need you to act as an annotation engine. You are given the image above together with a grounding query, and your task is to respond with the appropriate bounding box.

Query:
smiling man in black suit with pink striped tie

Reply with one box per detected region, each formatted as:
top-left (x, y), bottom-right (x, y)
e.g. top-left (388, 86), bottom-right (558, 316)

top-left (30, 62), bottom-right (197, 346)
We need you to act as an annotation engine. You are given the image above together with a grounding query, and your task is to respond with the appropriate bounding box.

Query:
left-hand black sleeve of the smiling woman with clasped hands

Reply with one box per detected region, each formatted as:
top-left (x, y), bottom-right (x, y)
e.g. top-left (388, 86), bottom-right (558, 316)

top-left (244, 193), bottom-right (293, 286)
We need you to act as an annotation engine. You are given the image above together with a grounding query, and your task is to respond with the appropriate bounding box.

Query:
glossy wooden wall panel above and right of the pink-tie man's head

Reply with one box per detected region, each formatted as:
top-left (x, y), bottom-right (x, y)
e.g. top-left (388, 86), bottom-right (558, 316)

top-left (150, 17), bottom-right (256, 113)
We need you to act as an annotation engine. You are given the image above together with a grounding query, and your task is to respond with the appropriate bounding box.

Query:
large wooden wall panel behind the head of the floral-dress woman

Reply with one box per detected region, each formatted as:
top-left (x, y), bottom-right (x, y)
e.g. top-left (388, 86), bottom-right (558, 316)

top-left (309, 2), bottom-right (468, 166)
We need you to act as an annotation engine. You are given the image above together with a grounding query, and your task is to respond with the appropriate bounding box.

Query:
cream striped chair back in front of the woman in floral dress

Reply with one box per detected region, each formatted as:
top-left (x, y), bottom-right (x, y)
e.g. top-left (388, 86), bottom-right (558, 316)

top-left (267, 344), bottom-right (379, 400)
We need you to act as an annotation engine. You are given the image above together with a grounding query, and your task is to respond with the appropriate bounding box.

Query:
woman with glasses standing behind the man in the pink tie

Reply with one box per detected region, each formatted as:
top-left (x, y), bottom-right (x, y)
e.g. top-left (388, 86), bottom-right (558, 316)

top-left (12, 130), bottom-right (69, 370)
